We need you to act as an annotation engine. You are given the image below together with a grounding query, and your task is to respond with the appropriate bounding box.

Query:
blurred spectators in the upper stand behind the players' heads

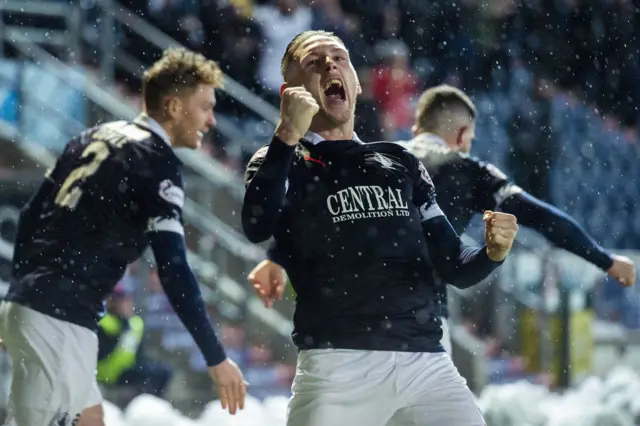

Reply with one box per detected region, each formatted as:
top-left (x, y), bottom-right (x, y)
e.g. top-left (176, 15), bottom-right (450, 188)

top-left (116, 0), bottom-right (640, 136)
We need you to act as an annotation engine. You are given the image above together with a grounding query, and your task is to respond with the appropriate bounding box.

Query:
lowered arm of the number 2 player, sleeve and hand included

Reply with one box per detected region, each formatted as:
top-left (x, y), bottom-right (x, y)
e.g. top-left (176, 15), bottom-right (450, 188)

top-left (147, 179), bottom-right (246, 414)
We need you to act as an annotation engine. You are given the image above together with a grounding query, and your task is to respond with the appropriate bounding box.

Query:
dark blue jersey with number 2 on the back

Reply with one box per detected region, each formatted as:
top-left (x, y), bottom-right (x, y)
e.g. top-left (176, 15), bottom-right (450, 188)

top-left (7, 120), bottom-right (184, 329)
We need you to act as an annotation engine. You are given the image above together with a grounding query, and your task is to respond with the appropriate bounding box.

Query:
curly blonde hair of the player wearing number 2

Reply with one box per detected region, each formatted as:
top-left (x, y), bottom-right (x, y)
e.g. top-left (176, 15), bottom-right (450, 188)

top-left (142, 48), bottom-right (222, 111)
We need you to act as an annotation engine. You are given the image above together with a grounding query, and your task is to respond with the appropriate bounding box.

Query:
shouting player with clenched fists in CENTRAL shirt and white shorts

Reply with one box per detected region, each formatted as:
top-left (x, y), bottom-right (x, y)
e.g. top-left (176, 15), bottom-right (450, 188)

top-left (242, 31), bottom-right (517, 426)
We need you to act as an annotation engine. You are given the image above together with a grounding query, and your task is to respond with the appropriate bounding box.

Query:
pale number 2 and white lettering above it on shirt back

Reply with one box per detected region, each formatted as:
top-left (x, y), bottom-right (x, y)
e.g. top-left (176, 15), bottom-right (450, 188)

top-left (55, 122), bottom-right (151, 210)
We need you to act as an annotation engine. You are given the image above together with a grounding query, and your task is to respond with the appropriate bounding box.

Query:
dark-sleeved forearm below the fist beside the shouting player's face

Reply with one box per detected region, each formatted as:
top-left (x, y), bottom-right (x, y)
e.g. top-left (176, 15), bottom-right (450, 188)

top-left (242, 137), bottom-right (295, 243)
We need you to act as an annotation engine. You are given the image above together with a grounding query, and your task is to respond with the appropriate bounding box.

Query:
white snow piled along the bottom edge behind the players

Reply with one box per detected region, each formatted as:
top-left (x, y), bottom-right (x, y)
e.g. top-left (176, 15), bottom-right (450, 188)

top-left (104, 367), bottom-right (640, 426)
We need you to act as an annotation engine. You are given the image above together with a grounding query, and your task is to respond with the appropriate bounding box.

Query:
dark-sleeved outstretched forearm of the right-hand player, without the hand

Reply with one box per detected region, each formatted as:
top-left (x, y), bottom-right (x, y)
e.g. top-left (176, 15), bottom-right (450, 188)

top-left (500, 192), bottom-right (613, 271)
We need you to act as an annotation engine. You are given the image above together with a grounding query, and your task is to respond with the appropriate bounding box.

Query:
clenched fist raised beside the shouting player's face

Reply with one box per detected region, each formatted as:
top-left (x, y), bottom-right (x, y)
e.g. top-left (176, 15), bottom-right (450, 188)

top-left (276, 86), bottom-right (320, 146)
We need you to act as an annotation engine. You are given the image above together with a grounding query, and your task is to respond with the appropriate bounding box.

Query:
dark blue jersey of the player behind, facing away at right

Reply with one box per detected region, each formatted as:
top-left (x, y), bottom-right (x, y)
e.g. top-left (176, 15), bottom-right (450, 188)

top-left (400, 133), bottom-right (613, 316)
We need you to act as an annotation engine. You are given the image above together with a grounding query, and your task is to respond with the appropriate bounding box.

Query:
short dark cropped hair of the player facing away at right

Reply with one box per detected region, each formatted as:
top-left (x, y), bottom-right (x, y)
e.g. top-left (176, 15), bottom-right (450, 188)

top-left (415, 84), bottom-right (477, 132)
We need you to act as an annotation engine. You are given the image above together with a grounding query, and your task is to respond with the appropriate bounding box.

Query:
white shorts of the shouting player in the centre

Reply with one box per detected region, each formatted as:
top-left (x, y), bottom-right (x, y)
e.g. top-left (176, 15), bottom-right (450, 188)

top-left (287, 349), bottom-right (485, 426)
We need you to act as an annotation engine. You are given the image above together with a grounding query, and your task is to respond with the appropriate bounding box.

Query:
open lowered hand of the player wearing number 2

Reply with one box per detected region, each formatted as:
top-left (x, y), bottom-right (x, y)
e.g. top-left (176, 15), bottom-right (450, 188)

top-left (209, 358), bottom-right (249, 414)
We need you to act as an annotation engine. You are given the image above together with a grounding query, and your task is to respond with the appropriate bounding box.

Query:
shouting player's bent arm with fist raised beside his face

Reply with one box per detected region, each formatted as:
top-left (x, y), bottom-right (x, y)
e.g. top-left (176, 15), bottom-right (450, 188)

top-left (242, 87), bottom-right (319, 243)
